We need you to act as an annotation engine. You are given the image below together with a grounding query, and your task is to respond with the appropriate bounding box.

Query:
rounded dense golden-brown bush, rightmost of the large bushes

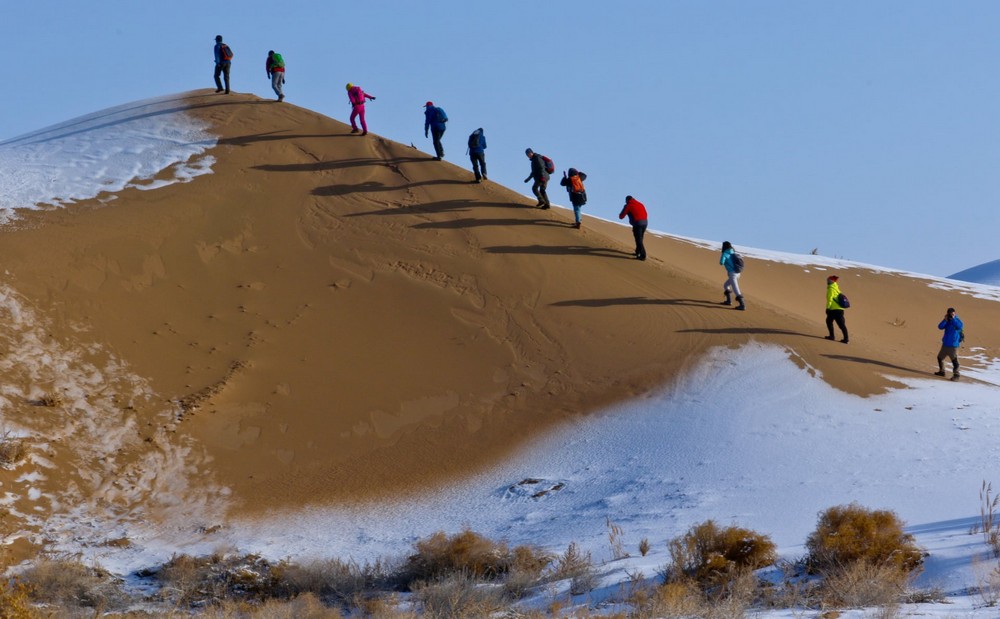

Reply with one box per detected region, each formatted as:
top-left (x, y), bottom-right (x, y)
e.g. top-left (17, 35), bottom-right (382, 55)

top-left (806, 503), bottom-right (923, 572)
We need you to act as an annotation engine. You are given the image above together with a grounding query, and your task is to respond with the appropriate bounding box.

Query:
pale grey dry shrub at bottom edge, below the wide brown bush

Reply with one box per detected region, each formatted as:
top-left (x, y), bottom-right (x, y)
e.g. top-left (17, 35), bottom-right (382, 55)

top-left (413, 573), bottom-right (504, 619)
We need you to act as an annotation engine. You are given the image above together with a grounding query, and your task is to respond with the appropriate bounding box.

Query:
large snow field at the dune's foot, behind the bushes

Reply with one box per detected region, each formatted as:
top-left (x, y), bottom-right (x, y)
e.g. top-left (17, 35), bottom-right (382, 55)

top-left (80, 344), bottom-right (1000, 617)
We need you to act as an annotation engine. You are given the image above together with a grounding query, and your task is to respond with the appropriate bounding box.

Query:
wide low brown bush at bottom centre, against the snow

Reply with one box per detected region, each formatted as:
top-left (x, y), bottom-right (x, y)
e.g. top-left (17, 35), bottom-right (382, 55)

top-left (405, 529), bottom-right (552, 583)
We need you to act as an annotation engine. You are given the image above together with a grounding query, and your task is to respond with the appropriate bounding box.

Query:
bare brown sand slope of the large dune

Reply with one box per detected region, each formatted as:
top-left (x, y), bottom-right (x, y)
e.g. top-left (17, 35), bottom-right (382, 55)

top-left (0, 91), bottom-right (1000, 548)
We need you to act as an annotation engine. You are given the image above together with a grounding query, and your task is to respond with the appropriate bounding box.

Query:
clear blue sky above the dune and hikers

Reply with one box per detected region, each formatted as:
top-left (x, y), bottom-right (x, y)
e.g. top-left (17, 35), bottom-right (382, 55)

top-left (7, 0), bottom-right (1000, 276)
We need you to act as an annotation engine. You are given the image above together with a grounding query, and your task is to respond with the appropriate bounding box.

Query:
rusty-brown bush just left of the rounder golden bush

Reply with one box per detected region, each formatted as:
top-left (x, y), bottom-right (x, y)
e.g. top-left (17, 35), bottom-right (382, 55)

top-left (665, 520), bottom-right (777, 589)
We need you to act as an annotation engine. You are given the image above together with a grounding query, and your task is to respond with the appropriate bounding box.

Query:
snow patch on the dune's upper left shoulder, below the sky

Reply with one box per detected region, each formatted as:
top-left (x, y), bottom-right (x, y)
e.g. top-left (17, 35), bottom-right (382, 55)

top-left (0, 97), bottom-right (217, 222)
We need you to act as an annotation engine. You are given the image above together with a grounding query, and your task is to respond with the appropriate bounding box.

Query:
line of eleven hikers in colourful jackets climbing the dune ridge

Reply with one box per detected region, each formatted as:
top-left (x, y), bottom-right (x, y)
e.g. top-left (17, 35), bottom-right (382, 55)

top-left (214, 34), bottom-right (965, 380)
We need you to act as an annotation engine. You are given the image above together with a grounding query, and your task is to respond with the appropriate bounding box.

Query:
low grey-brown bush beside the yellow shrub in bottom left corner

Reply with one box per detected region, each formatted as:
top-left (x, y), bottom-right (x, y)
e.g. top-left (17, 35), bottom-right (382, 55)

top-left (21, 559), bottom-right (128, 611)
